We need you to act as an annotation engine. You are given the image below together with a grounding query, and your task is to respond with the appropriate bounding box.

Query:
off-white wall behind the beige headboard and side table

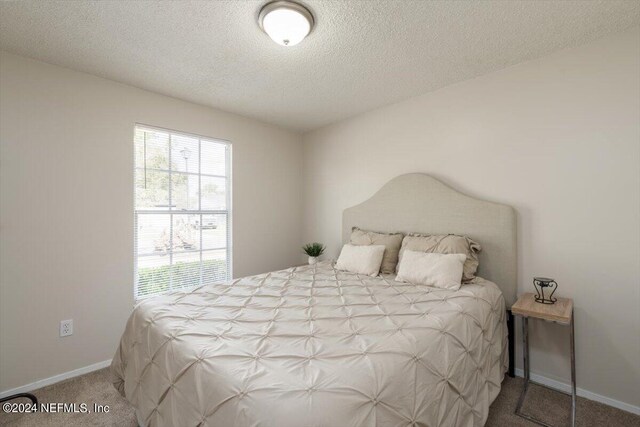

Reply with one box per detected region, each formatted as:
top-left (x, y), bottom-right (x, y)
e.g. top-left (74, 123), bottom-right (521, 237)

top-left (303, 28), bottom-right (640, 406)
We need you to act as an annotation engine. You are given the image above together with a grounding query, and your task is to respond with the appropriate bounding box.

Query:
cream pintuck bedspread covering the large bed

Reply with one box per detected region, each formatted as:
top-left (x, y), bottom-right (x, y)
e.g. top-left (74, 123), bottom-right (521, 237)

top-left (111, 263), bottom-right (507, 427)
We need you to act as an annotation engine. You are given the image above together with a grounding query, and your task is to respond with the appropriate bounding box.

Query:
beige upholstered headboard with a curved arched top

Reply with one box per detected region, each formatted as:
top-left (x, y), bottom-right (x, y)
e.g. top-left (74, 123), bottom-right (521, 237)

top-left (342, 173), bottom-right (517, 307)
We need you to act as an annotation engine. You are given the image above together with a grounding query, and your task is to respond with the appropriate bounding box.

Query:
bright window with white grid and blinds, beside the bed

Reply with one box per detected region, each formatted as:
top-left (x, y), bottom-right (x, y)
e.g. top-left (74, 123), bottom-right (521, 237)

top-left (134, 126), bottom-right (231, 299)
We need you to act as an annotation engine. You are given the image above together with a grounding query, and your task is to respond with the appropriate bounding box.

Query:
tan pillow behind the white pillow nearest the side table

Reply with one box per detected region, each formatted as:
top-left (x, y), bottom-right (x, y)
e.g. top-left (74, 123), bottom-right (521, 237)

top-left (398, 233), bottom-right (482, 283)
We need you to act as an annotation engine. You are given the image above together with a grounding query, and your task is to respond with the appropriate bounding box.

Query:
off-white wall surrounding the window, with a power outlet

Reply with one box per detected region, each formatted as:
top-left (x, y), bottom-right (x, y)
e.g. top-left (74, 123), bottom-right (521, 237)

top-left (0, 53), bottom-right (302, 390)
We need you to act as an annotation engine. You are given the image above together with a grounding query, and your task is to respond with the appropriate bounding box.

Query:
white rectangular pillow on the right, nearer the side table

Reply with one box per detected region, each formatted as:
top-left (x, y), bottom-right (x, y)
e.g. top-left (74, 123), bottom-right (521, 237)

top-left (396, 250), bottom-right (467, 290)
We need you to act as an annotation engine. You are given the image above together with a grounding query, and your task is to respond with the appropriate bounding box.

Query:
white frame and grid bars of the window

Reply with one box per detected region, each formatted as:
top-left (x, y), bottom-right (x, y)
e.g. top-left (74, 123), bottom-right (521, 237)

top-left (132, 123), bottom-right (233, 301)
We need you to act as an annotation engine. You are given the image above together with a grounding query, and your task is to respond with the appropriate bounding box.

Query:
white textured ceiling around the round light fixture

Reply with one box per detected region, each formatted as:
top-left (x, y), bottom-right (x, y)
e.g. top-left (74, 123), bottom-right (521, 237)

top-left (0, 0), bottom-right (640, 130)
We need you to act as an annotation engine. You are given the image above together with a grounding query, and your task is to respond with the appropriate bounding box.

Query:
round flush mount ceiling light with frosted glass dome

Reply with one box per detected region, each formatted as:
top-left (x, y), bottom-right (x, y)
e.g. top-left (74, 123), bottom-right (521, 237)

top-left (258, 0), bottom-right (313, 46)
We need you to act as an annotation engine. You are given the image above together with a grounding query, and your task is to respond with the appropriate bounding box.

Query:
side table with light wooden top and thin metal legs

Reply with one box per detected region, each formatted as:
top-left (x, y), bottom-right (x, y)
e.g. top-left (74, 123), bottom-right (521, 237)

top-left (511, 293), bottom-right (576, 427)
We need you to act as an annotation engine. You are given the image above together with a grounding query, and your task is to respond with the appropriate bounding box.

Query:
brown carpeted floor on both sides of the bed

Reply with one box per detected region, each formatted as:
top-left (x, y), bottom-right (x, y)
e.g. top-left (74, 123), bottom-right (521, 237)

top-left (0, 369), bottom-right (640, 427)
